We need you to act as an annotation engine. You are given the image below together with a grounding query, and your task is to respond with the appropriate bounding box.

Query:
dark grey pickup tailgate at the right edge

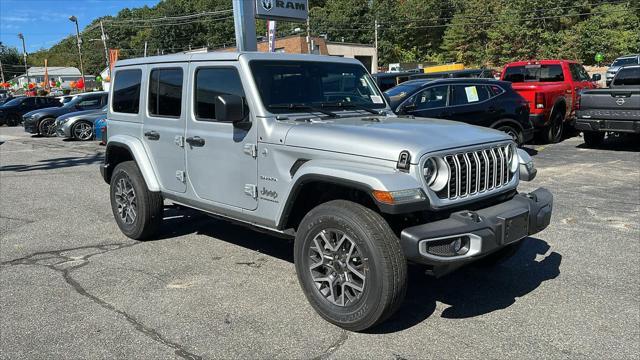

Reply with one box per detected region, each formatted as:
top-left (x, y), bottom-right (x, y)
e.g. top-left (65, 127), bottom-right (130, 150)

top-left (577, 89), bottom-right (640, 121)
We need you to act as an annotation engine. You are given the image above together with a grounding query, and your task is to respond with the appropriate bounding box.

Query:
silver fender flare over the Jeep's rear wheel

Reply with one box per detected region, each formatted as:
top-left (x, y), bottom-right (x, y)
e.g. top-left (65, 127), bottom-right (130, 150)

top-left (104, 135), bottom-right (160, 192)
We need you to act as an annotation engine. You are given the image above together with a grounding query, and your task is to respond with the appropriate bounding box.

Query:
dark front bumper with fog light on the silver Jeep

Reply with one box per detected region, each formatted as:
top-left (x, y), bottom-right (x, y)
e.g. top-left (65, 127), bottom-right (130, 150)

top-left (400, 188), bottom-right (553, 269)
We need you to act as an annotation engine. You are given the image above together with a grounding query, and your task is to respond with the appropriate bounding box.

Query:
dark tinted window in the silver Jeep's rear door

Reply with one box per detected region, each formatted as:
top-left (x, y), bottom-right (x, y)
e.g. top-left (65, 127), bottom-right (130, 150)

top-left (149, 69), bottom-right (182, 117)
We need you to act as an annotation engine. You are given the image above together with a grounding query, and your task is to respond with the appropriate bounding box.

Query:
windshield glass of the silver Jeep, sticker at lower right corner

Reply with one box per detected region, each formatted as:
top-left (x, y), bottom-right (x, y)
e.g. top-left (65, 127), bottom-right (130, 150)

top-left (250, 60), bottom-right (385, 113)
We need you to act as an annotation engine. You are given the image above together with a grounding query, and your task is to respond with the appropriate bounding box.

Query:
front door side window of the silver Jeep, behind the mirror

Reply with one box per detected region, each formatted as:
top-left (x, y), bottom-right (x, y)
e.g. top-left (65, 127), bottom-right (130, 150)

top-left (194, 68), bottom-right (244, 121)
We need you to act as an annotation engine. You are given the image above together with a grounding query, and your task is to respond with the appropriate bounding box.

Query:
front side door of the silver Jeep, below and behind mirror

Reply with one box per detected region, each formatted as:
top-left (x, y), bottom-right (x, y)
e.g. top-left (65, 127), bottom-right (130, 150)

top-left (185, 63), bottom-right (258, 210)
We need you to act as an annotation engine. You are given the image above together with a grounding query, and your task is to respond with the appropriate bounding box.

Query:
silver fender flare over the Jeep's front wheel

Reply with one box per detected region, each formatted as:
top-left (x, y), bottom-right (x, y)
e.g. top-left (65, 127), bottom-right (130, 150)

top-left (276, 160), bottom-right (429, 229)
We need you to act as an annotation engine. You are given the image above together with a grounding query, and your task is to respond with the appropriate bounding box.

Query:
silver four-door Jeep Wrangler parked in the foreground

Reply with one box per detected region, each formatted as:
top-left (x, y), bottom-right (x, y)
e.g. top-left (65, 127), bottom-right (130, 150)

top-left (101, 52), bottom-right (553, 331)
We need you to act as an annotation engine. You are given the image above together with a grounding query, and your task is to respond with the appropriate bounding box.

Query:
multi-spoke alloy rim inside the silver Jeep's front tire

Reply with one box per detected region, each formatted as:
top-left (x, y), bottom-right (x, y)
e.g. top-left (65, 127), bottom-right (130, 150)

top-left (308, 229), bottom-right (367, 307)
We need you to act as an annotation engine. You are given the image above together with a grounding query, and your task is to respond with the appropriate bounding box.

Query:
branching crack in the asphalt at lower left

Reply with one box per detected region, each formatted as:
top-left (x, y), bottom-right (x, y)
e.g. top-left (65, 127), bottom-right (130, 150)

top-left (0, 242), bottom-right (202, 360)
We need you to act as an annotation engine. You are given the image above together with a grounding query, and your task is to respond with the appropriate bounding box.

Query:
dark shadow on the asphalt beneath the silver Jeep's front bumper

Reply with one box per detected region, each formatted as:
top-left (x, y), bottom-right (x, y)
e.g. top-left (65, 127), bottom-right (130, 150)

top-left (369, 237), bottom-right (562, 333)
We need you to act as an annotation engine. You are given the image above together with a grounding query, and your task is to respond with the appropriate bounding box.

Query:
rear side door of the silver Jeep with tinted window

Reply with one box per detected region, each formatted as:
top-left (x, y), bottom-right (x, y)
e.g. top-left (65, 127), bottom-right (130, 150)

top-left (142, 64), bottom-right (188, 192)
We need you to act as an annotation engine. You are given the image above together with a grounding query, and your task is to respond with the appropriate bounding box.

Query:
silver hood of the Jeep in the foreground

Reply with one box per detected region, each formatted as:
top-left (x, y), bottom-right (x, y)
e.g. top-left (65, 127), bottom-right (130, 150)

top-left (285, 116), bottom-right (511, 163)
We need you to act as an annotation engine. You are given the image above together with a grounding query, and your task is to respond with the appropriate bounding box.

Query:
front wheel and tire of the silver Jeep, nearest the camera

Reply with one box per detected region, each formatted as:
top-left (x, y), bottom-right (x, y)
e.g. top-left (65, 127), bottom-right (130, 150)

top-left (294, 200), bottom-right (407, 331)
